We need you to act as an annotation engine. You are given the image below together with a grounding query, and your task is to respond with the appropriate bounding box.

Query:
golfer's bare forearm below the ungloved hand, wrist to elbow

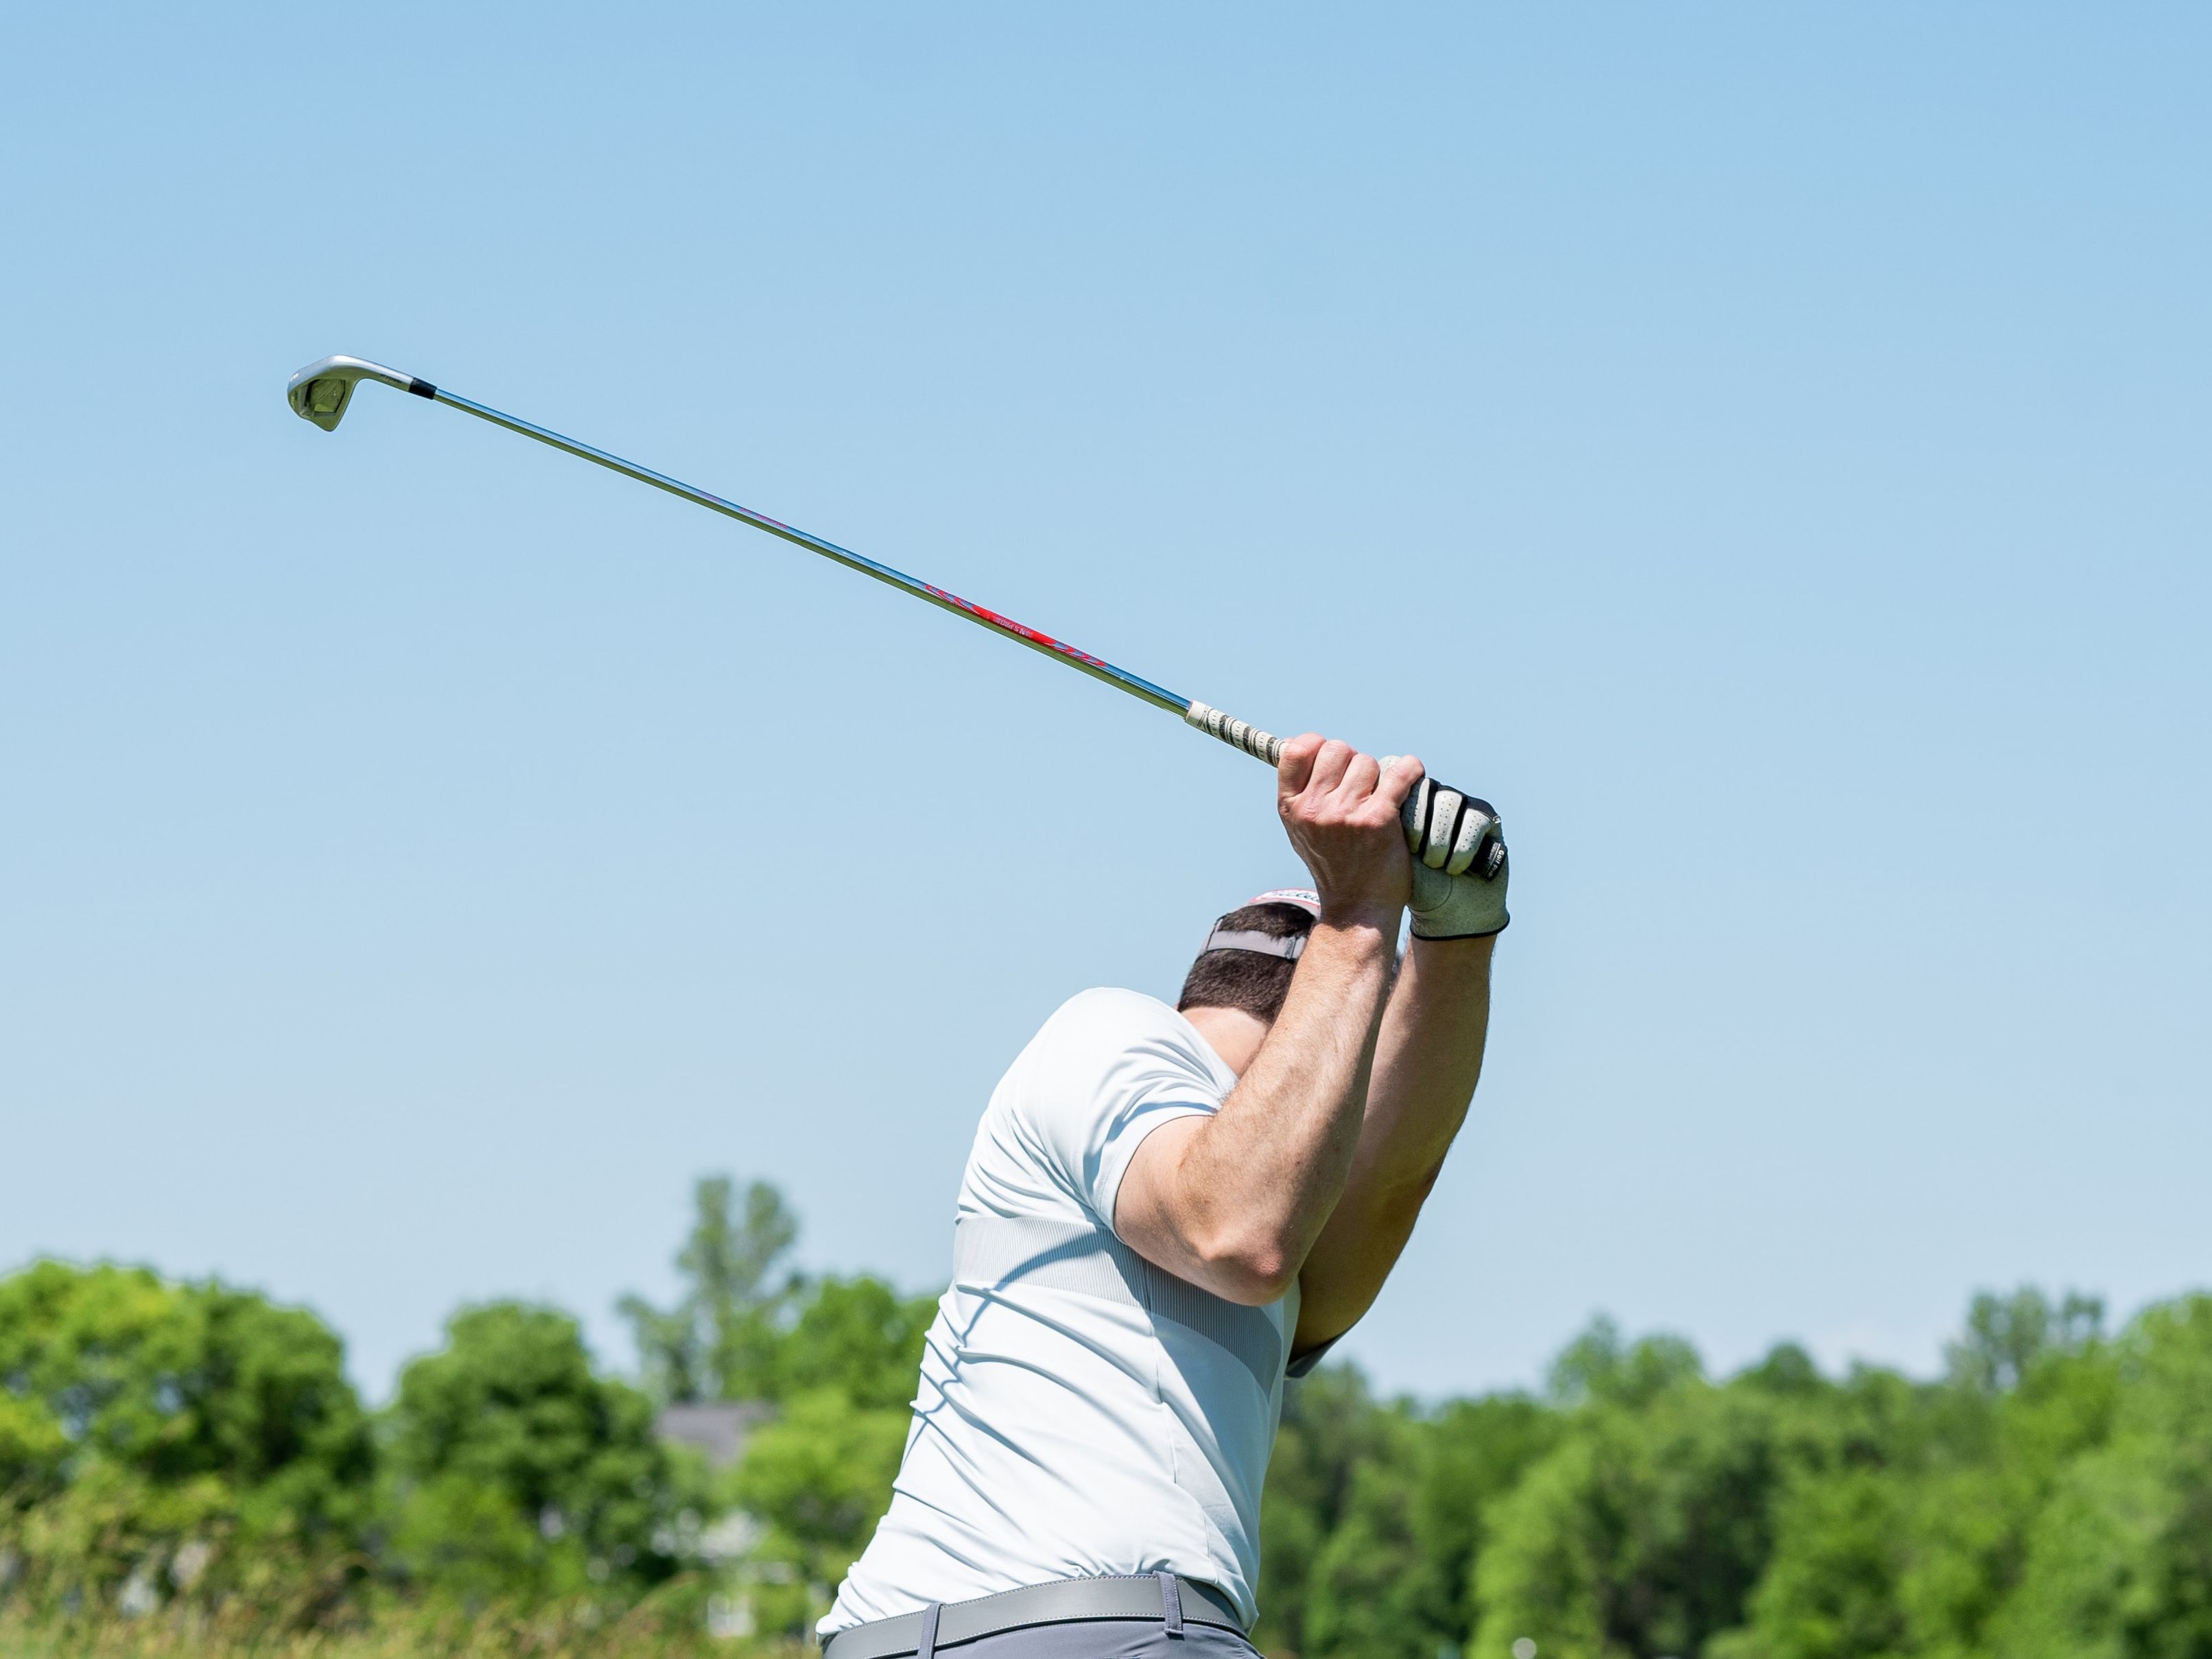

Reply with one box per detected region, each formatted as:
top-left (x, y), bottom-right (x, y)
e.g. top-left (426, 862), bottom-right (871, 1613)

top-left (1132, 916), bottom-right (1396, 1303)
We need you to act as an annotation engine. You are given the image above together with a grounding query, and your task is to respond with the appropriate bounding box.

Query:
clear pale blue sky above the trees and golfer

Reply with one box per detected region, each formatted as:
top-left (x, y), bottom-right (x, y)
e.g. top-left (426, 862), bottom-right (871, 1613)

top-left (0, 4), bottom-right (2212, 1393)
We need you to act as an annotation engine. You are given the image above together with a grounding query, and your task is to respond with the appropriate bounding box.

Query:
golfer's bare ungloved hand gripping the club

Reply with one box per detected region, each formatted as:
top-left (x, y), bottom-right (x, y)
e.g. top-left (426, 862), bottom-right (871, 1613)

top-left (1274, 732), bottom-right (1420, 927)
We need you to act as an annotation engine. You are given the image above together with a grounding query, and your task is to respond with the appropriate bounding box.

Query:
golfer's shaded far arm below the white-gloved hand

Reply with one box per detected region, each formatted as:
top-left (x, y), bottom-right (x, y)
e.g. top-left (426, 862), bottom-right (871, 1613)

top-left (1292, 938), bottom-right (1498, 1352)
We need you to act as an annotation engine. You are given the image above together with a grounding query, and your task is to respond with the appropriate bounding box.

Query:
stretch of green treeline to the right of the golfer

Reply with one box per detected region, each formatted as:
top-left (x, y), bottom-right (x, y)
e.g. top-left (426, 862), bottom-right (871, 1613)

top-left (1258, 1290), bottom-right (2212, 1659)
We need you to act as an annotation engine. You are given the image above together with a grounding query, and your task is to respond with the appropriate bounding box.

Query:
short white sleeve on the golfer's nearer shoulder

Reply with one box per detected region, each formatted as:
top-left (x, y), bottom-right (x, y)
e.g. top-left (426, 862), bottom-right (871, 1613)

top-left (1017, 991), bottom-right (1236, 1230)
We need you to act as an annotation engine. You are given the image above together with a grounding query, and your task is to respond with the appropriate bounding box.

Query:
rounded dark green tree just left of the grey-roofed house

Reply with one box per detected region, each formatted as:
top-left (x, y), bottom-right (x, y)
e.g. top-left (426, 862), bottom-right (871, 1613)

top-left (385, 1303), bottom-right (699, 1601)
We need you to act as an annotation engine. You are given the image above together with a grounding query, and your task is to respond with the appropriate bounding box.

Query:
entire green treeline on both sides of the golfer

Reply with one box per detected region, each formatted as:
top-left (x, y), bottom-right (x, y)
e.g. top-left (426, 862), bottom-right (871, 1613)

top-left (0, 1181), bottom-right (2212, 1659)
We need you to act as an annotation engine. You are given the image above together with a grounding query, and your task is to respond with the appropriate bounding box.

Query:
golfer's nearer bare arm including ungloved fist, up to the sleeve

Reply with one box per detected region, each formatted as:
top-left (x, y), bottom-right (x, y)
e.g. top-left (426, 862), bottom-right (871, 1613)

top-left (1113, 737), bottom-right (1420, 1305)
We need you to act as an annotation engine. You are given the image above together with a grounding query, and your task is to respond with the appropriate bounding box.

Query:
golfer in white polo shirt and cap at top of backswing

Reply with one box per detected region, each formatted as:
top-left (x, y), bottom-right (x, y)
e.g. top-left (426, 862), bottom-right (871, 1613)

top-left (821, 734), bottom-right (1507, 1659)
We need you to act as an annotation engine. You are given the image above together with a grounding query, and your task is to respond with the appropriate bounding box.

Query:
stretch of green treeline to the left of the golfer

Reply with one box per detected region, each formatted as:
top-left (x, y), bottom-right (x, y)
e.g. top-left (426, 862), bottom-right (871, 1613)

top-left (0, 1179), bottom-right (936, 1632)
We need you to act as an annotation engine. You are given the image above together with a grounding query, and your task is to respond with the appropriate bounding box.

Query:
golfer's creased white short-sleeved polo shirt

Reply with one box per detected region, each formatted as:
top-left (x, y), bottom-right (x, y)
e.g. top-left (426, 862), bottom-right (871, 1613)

top-left (821, 991), bottom-right (1319, 1635)
